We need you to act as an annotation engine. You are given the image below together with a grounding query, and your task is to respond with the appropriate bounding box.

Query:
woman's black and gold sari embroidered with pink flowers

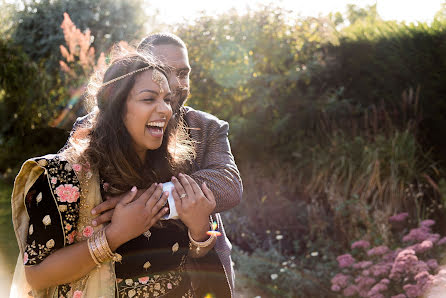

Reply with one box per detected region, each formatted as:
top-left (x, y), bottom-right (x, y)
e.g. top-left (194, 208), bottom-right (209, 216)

top-left (10, 155), bottom-right (200, 297)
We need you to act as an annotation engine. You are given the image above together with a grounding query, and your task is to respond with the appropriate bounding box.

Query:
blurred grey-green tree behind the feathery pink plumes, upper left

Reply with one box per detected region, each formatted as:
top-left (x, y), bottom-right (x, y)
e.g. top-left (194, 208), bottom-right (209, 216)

top-left (12, 0), bottom-right (148, 72)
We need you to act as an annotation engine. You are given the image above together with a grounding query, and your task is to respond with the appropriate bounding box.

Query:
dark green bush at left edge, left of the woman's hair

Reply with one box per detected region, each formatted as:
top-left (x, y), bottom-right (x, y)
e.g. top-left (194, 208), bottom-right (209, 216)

top-left (0, 39), bottom-right (66, 174)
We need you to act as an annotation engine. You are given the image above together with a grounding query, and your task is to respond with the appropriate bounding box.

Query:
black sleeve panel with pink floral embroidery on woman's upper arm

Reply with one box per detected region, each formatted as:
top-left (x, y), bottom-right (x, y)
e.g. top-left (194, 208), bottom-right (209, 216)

top-left (24, 155), bottom-right (80, 297)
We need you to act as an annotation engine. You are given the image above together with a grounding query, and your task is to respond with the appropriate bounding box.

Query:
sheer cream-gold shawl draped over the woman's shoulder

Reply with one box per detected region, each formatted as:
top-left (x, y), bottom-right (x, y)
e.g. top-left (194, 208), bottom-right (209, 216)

top-left (10, 155), bottom-right (116, 298)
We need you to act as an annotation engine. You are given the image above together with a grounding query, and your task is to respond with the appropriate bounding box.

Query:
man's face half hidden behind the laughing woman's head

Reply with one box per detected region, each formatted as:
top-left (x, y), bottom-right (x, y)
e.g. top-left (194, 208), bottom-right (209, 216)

top-left (152, 44), bottom-right (191, 112)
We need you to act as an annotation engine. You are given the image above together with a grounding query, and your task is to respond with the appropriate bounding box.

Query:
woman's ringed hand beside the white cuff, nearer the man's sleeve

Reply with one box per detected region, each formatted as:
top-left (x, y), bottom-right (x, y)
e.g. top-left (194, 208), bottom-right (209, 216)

top-left (172, 174), bottom-right (216, 241)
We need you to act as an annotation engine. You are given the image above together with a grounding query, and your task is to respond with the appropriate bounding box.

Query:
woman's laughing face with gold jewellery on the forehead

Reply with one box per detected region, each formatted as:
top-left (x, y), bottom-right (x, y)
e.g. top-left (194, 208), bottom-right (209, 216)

top-left (123, 70), bottom-right (172, 160)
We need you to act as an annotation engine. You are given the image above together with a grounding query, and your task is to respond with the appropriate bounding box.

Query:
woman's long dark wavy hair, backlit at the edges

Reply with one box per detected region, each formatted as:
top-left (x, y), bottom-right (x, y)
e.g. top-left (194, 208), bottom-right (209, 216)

top-left (63, 48), bottom-right (195, 194)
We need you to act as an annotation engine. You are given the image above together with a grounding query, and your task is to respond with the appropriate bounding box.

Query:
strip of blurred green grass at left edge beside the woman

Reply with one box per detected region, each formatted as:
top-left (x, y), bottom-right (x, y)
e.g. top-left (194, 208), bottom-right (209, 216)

top-left (0, 180), bottom-right (18, 293)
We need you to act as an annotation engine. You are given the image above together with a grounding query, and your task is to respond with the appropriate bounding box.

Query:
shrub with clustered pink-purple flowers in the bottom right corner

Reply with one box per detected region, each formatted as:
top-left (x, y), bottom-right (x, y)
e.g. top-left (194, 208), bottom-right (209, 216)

top-left (331, 213), bottom-right (446, 298)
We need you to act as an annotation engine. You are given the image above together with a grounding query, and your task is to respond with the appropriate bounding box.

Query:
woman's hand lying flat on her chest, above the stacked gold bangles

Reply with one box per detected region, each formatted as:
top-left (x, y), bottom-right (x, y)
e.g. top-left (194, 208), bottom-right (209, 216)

top-left (105, 183), bottom-right (169, 251)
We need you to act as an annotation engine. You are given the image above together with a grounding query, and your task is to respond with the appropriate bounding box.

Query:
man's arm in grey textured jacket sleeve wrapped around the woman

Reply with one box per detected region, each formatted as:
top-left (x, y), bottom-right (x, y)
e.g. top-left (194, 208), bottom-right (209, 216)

top-left (184, 107), bottom-right (243, 213)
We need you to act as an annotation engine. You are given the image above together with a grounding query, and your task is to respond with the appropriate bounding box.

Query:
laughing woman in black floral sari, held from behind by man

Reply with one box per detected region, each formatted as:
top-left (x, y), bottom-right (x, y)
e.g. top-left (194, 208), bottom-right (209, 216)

top-left (11, 47), bottom-right (220, 297)
